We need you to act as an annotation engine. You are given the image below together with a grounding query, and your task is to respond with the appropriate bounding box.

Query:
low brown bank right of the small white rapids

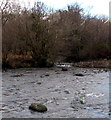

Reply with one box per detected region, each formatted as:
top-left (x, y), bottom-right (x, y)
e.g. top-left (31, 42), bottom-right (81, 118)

top-left (73, 59), bottom-right (111, 68)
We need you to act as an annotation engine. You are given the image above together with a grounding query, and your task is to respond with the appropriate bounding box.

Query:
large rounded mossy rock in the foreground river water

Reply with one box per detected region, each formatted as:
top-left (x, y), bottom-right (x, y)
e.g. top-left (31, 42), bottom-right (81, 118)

top-left (29, 103), bottom-right (47, 112)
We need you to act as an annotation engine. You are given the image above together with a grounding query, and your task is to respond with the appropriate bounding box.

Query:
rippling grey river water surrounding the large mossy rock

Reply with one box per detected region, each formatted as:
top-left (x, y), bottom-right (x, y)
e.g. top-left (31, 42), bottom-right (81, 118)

top-left (1, 67), bottom-right (109, 118)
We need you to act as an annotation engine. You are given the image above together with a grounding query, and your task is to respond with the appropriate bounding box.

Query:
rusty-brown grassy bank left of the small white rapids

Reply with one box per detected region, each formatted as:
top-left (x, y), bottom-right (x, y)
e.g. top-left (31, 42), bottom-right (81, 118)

top-left (2, 54), bottom-right (53, 69)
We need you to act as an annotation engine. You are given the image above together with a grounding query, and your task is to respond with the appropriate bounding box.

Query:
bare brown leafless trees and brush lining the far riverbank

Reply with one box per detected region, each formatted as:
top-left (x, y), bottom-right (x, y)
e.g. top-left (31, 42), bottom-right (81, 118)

top-left (0, 0), bottom-right (110, 68)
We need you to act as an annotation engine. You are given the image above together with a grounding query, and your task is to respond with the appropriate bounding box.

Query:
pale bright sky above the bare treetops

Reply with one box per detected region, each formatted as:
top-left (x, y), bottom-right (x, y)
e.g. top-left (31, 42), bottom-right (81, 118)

top-left (20, 0), bottom-right (111, 16)
